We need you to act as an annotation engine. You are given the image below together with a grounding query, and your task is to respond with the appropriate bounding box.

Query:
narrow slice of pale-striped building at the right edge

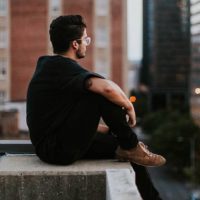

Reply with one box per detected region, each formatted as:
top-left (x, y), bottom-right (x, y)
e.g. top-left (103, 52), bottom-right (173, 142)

top-left (190, 0), bottom-right (200, 125)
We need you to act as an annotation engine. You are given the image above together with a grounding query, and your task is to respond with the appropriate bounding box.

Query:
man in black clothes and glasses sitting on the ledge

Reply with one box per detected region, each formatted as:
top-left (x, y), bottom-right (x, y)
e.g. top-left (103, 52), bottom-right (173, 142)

top-left (27, 15), bottom-right (165, 200)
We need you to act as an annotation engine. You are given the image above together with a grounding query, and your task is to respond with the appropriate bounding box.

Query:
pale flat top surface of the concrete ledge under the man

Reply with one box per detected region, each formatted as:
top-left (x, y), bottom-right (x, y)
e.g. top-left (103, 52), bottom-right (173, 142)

top-left (0, 154), bottom-right (132, 175)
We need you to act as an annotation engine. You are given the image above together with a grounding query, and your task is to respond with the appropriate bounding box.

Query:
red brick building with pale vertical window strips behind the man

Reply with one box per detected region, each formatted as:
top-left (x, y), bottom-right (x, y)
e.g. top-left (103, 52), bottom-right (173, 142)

top-left (0, 0), bottom-right (128, 101)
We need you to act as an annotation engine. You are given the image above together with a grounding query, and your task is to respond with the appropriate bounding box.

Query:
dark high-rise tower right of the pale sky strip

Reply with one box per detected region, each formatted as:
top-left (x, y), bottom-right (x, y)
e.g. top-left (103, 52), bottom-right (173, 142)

top-left (140, 0), bottom-right (190, 110)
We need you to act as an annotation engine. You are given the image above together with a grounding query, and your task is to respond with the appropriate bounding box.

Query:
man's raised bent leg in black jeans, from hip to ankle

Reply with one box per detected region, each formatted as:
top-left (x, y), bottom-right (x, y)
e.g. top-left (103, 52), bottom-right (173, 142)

top-left (36, 92), bottom-right (138, 165)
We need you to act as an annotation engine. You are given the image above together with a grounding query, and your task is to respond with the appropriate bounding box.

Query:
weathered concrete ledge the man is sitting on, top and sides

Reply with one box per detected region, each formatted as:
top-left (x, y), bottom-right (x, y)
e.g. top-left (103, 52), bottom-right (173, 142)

top-left (0, 155), bottom-right (141, 200)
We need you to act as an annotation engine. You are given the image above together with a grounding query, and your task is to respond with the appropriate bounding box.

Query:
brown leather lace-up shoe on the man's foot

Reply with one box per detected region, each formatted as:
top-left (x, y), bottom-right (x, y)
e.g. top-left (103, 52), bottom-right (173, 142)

top-left (116, 142), bottom-right (166, 167)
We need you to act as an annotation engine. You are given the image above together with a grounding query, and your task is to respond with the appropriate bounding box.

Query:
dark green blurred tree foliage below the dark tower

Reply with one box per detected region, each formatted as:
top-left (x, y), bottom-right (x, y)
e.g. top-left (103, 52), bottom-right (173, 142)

top-left (142, 110), bottom-right (200, 180)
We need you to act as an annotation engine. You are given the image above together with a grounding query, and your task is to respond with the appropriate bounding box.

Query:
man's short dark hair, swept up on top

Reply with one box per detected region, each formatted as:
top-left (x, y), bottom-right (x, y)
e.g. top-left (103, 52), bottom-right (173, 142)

top-left (49, 15), bottom-right (86, 53)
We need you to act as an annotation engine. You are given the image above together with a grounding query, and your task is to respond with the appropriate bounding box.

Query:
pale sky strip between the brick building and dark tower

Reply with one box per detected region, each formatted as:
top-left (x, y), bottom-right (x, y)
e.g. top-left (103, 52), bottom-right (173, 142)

top-left (127, 0), bottom-right (143, 60)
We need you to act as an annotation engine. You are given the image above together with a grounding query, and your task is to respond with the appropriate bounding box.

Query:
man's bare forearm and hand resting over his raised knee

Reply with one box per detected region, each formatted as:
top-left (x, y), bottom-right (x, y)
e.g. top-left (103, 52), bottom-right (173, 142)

top-left (86, 77), bottom-right (136, 126)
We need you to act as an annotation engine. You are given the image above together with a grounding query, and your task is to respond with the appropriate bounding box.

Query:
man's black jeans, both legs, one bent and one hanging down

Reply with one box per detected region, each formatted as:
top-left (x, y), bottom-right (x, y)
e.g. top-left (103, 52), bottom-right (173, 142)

top-left (37, 93), bottom-right (159, 200)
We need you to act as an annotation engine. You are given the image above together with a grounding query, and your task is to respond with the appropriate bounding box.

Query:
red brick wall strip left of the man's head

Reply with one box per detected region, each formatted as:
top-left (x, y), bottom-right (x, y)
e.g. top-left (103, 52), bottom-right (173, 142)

top-left (10, 0), bottom-right (48, 100)
